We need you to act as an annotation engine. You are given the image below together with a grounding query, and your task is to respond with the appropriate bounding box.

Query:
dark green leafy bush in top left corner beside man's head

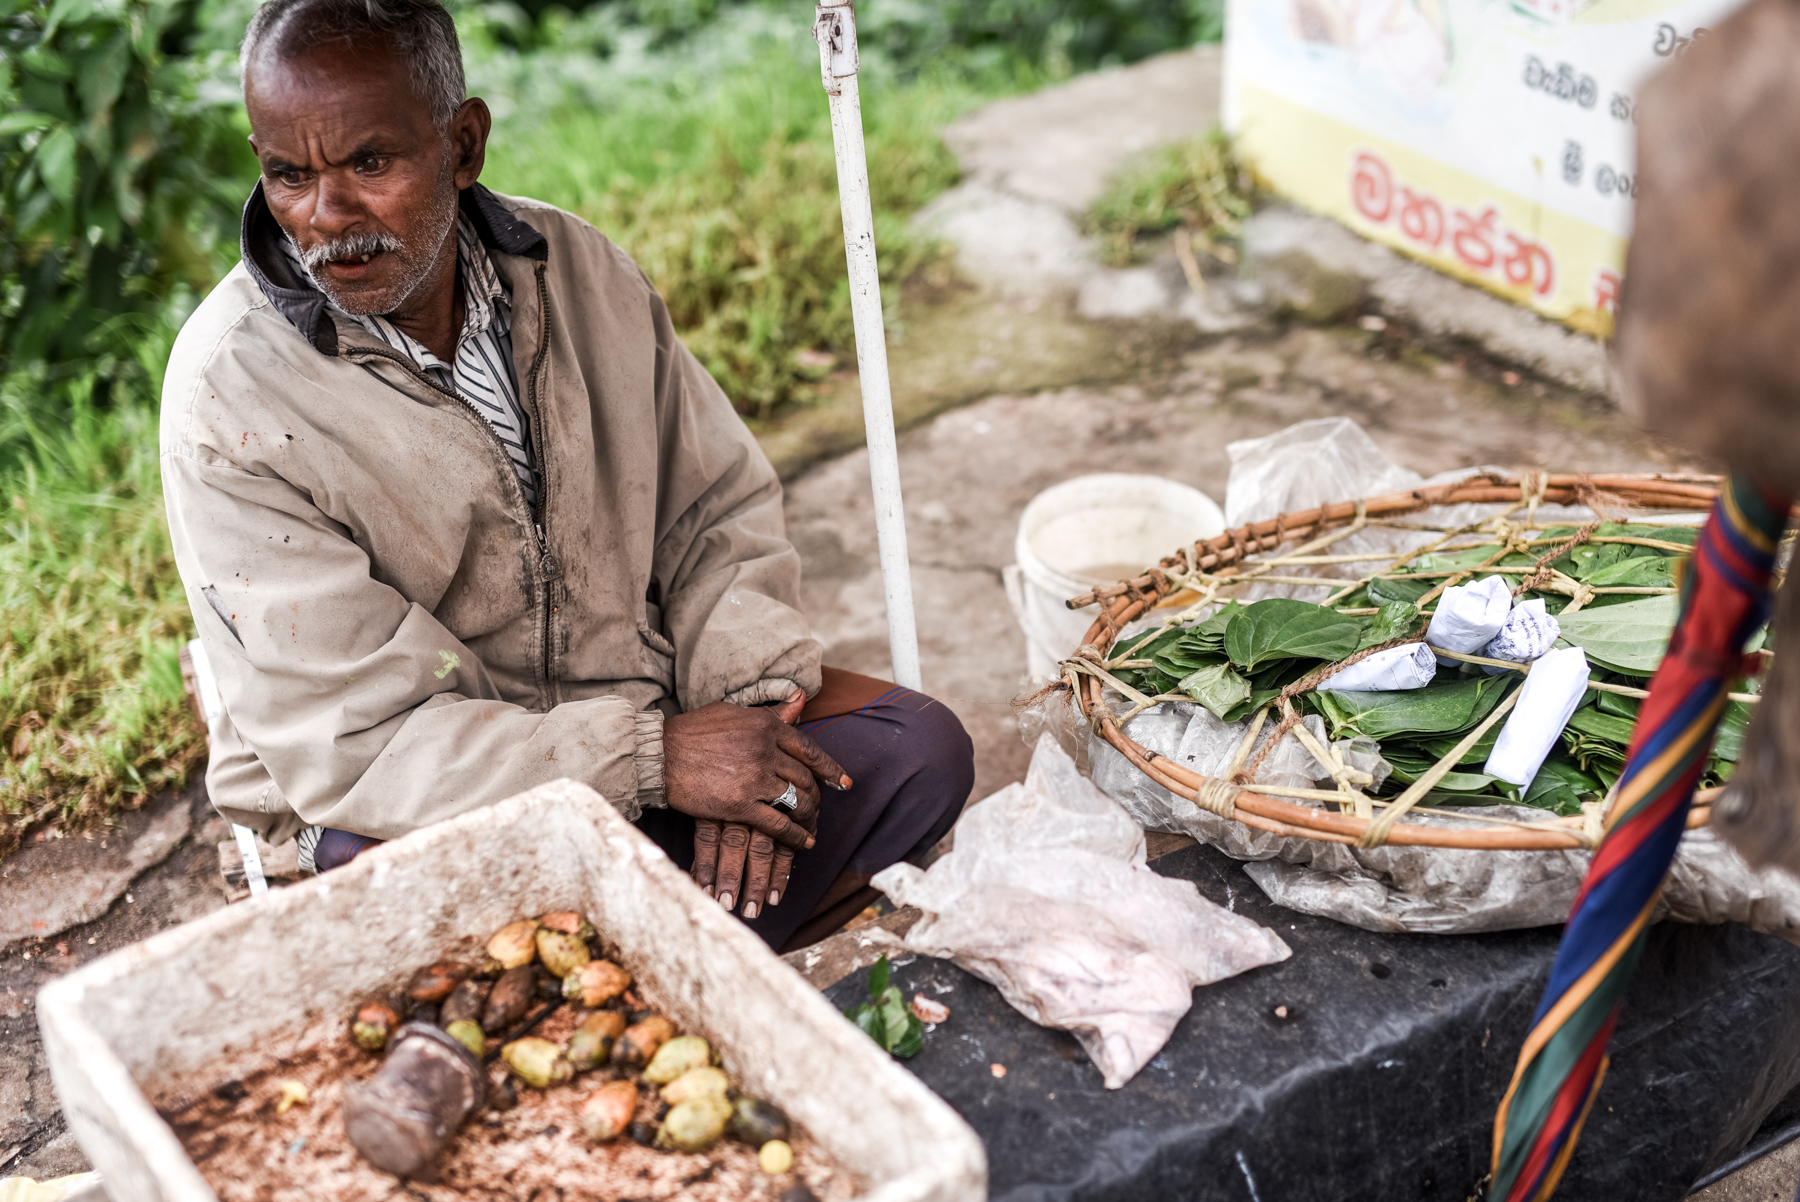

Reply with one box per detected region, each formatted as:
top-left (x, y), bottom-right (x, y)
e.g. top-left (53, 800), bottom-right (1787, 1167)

top-left (0, 0), bottom-right (256, 383)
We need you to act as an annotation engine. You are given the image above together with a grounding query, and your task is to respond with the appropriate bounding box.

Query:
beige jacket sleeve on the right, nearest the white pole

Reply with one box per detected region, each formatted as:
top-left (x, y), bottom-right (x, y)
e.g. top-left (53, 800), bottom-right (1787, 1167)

top-left (652, 292), bottom-right (821, 711)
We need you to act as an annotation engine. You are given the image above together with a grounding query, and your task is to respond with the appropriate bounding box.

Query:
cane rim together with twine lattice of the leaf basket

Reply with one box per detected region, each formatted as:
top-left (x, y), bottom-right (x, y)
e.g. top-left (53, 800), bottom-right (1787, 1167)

top-left (1062, 471), bottom-right (1755, 851)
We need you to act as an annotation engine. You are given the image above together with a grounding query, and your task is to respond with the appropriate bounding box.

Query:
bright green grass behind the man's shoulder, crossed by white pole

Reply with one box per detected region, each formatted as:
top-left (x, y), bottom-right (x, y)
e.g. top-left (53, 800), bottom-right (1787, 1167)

top-left (482, 29), bottom-right (972, 421)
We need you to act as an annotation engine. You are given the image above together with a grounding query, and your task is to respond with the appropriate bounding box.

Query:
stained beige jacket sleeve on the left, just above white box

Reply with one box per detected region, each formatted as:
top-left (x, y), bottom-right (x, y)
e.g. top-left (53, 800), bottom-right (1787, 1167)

top-left (164, 443), bottom-right (662, 839)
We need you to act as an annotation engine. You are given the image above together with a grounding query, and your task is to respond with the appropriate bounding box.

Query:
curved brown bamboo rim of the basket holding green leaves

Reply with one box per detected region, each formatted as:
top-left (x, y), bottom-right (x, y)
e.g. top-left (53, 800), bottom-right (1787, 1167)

top-left (1064, 471), bottom-right (1723, 851)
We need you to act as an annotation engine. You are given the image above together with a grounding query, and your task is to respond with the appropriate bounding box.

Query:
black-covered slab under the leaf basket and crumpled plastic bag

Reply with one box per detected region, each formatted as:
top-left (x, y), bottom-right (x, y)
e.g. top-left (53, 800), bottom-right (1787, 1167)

top-left (828, 848), bottom-right (1800, 1202)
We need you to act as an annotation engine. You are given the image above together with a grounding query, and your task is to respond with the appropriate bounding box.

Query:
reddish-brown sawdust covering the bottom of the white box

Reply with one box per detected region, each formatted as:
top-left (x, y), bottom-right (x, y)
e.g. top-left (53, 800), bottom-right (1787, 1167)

top-left (155, 1006), bottom-right (855, 1202)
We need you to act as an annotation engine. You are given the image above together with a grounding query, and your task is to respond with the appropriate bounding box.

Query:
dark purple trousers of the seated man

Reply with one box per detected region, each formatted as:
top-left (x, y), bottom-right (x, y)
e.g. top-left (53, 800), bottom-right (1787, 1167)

top-left (313, 678), bottom-right (976, 950)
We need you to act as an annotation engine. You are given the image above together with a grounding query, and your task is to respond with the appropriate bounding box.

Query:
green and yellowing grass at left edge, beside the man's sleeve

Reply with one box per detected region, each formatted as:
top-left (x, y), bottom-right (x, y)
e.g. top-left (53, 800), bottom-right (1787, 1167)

top-left (0, 329), bottom-right (205, 853)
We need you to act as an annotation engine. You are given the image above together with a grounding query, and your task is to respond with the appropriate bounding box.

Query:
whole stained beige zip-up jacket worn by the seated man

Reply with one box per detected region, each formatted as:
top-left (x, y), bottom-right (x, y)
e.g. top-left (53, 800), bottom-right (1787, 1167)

top-left (162, 185), bottom-right (819, 842)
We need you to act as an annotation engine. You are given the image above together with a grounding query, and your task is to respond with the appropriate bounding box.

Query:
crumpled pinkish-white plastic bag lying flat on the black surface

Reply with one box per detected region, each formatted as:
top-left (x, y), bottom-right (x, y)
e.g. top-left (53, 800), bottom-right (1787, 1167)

top-left (873, 732), bottom-right (1292, 1089)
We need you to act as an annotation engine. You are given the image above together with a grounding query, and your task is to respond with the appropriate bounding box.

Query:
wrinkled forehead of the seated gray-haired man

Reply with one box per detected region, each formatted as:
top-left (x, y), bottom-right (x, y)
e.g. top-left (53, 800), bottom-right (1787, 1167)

top-left (243, 31), bottom-right (436, 146)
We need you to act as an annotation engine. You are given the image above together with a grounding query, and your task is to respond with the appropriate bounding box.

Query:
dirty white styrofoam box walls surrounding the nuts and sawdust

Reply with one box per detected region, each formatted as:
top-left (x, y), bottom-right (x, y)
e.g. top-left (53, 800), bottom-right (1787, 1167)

top-left (38, 781), bottom-right (986, 1202)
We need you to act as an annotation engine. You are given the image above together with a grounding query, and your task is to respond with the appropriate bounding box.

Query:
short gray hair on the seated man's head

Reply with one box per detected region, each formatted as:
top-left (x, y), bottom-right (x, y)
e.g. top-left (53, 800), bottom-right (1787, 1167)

top-left (239, 0), bottom-right (468, 130)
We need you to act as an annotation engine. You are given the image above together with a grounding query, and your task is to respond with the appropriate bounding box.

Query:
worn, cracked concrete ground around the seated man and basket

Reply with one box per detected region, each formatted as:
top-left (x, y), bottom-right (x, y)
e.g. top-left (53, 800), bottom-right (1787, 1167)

top-left (0, 42), bottom-right (1800, 1202)
